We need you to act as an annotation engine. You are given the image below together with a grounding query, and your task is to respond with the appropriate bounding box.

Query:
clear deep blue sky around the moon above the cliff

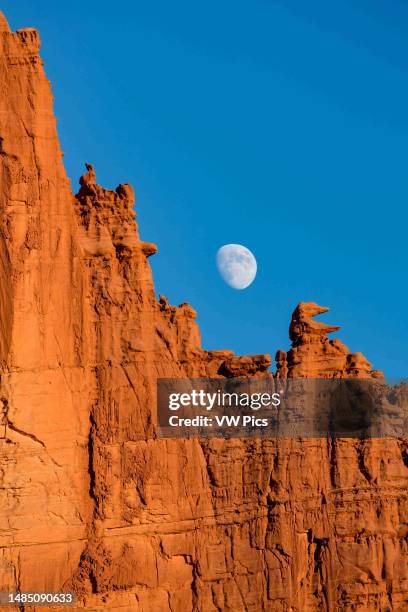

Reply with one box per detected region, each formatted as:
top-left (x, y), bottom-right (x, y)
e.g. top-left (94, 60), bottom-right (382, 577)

top-left (1, 0), bottom-right (408, 377)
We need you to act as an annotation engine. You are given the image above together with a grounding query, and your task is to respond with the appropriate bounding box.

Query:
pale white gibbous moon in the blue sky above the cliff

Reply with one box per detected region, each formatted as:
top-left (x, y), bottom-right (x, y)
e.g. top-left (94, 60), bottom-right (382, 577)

top-left (217, 244), bottom-right (257, 289)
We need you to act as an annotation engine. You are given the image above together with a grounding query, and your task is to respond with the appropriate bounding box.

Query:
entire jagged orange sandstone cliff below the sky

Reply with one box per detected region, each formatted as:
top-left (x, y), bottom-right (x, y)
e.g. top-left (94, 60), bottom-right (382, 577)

top-left (0, 16), bottom-right (408, 612)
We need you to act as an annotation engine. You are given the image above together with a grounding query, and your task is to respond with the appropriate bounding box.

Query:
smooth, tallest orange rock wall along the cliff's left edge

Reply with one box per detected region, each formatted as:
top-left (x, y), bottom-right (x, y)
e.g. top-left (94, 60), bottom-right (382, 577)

top-left (0, 16), bottom-right (92, 590)
